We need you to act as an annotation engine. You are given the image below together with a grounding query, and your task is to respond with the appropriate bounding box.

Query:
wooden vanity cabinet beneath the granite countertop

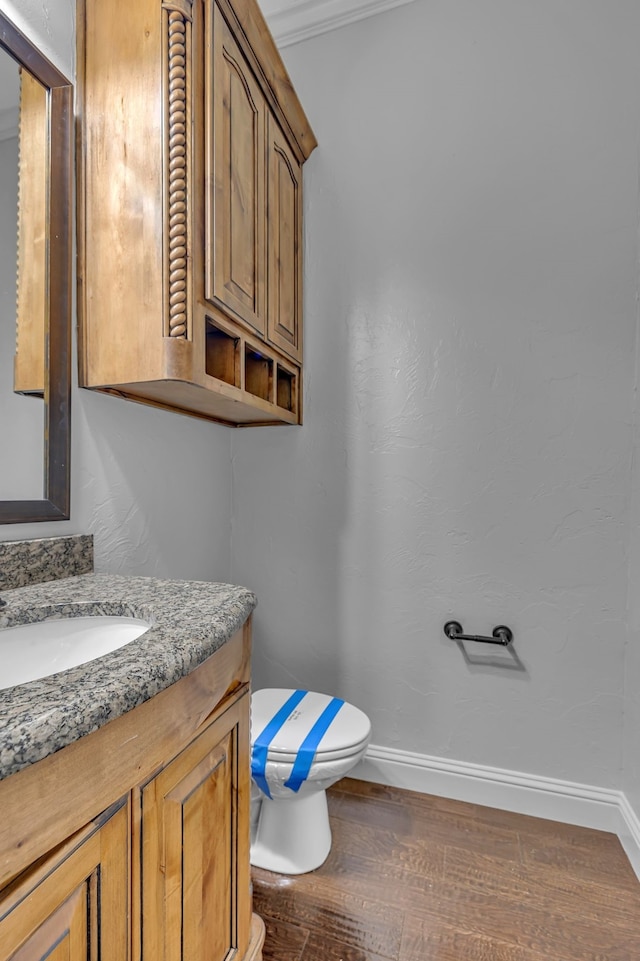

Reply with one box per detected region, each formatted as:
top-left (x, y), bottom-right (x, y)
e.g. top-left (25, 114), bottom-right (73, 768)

top-left (0, 624), bottom-right (264, 961)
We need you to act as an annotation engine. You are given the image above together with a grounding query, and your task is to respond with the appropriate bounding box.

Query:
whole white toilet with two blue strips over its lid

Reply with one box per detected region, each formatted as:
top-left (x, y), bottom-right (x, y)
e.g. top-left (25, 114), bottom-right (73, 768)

top-left (251, 688), bottom-right (371, 874)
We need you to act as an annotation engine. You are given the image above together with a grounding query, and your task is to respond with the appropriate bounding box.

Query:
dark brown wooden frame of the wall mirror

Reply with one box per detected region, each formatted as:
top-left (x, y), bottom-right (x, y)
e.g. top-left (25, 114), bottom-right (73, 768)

top-left (0, 12), bottom-right (73, 524)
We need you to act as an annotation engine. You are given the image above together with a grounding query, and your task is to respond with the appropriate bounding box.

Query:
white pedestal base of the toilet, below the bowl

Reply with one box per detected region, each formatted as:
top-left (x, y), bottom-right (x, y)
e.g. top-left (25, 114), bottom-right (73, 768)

top-left (251, 791), bottom-right (331, 874)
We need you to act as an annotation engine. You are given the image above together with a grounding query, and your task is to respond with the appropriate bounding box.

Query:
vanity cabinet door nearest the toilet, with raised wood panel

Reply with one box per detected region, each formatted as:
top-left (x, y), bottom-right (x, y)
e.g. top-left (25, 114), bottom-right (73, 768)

top-left (139, 695), bottom-right (251, 961)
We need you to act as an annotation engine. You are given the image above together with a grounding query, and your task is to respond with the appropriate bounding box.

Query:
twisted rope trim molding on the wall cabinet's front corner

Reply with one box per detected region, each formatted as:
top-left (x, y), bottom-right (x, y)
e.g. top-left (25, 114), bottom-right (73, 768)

top-left (163, 0), bottom-right (191, 339)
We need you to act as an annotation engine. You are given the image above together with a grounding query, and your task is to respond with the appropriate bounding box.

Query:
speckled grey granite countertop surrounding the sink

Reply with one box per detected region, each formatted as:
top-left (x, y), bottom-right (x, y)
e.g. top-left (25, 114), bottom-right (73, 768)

top-left (0, 574), bottom-right (257, 779)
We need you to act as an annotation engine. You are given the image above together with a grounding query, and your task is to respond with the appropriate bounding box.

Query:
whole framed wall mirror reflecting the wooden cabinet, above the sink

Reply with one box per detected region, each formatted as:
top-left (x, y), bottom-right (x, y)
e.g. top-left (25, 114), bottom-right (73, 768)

top-left (0, 12), bottom-right (73, 524)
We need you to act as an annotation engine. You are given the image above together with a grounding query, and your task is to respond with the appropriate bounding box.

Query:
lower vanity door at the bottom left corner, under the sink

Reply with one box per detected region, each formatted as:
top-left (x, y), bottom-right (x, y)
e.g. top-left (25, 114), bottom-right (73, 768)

top-left (0, 801), bottom-right (129, 961)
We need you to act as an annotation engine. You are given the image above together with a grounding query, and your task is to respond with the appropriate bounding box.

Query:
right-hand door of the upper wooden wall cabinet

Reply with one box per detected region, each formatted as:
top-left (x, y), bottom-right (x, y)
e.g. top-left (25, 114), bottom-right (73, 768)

top-left (267, 117), bottom-right (302, 361)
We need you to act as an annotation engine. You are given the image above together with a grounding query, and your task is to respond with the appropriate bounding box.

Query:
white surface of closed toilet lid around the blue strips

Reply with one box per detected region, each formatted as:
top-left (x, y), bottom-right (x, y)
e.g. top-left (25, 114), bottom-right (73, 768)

top-left (251, 688), bottom-right (371, 761)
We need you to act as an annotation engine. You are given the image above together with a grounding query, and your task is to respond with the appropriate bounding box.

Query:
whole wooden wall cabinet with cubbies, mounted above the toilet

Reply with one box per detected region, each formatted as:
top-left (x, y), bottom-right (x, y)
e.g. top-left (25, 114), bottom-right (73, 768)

top-left (78, 0), bottom-right (316, 426)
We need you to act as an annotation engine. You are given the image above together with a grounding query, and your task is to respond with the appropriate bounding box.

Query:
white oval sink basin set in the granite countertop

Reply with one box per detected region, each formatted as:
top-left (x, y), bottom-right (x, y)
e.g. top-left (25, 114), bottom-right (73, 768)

top-left (0, 615), bottom-right (151, 690)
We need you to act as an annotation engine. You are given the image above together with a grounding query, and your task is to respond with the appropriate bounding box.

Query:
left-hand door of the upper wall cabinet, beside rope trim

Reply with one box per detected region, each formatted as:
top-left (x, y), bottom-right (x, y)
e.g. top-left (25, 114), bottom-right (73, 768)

top-left (205, 0), bottom-right (266, 334)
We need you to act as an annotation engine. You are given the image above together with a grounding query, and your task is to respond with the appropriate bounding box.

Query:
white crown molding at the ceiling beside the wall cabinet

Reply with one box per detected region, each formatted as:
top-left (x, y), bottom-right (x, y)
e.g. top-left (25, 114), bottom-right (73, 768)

top-left (261, 0), bottom-right (414, 47)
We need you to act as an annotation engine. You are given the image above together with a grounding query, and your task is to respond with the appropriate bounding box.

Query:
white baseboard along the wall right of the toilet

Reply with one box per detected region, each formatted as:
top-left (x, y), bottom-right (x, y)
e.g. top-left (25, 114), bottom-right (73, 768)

top-left (350, 744), bottom-right (640, 879)
